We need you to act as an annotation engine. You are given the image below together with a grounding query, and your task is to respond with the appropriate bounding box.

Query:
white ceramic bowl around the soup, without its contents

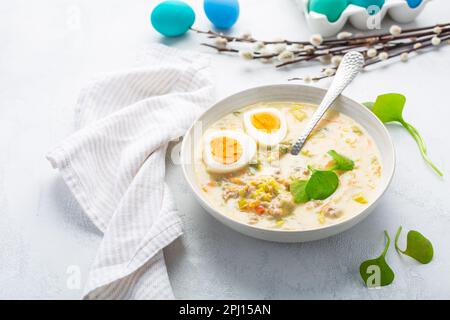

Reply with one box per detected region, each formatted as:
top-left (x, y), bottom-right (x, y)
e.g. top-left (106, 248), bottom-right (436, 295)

top-left (181, 84), bottom-right (395, 242)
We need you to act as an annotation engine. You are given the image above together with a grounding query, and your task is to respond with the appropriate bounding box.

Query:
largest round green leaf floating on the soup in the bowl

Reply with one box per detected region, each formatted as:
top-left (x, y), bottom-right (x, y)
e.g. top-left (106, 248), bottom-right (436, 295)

top-left (305, 170), bottom-right (339, 200)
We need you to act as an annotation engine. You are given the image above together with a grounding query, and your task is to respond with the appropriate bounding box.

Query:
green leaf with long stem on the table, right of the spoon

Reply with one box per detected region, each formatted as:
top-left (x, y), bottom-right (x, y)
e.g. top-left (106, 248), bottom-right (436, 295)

top-left (363, 93), bottom-right (444, 177)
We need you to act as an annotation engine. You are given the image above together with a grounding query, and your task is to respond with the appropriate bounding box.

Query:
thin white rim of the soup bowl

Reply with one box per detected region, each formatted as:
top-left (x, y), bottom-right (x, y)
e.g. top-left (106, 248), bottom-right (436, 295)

top-left (180, 84), bottom-right (396, 235)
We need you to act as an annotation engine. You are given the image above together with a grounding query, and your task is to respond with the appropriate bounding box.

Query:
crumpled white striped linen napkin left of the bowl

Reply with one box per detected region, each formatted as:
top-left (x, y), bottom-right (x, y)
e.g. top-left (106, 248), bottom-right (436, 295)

top-left (47, 45), bottom-right (212, 299)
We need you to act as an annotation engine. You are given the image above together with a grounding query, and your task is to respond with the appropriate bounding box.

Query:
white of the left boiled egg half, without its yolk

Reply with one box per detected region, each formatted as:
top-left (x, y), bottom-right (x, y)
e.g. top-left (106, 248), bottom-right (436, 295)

top-left (203, 130), bottom-right (256, 173)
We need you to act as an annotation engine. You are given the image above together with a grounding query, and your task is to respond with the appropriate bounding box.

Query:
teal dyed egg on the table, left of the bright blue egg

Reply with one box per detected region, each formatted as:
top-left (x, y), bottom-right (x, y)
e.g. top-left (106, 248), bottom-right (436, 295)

top-left (150, 0), bottom-right (195, 37)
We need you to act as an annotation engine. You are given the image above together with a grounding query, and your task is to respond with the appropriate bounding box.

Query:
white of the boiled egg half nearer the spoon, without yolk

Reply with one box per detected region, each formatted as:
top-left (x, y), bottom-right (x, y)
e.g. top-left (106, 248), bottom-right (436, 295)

top-left (243, 108), bottom-right (287, 146)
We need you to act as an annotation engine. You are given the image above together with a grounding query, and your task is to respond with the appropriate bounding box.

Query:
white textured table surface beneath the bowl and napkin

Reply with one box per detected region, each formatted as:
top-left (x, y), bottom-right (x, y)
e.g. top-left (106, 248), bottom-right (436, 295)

top-left (0, 0), bottom-right (450, 299)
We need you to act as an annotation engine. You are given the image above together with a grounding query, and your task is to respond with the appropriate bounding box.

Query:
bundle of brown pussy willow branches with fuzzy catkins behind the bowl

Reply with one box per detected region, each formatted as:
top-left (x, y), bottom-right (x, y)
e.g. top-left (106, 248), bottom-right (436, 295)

top-left (191, 23), bottom-right (450, 80)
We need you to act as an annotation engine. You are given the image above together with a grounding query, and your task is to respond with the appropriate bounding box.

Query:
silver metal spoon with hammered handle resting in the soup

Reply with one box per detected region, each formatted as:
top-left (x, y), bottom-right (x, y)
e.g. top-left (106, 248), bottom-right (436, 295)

top-left (291, 51), bottom-right (364, 156)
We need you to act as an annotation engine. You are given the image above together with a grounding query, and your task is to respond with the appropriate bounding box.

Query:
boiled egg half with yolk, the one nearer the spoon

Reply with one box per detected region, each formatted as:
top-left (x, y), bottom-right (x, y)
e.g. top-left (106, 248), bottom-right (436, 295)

top-left (243, 108), bottom-right (287, 146)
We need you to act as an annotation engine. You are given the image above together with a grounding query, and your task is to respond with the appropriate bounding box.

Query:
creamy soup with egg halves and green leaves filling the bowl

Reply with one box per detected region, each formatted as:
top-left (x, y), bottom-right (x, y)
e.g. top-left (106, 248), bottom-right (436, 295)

top-left (195, 102), bottom-right (382, 230)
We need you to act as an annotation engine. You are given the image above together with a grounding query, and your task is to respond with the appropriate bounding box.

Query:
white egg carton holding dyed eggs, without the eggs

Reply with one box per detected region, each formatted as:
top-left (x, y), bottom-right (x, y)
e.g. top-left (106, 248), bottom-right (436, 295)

top-left (297, 0), bottom-right (431, 37)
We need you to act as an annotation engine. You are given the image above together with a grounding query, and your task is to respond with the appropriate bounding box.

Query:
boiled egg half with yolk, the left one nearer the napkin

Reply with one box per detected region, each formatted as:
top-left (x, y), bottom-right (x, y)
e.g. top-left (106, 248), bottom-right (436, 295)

top-left (203, 130), bottom-right (256, 173)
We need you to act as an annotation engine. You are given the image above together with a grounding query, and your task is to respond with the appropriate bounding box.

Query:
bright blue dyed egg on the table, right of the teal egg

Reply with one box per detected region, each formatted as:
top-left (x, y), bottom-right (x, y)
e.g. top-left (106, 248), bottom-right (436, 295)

top-left (203, 0), bottom-right (239, 29)
